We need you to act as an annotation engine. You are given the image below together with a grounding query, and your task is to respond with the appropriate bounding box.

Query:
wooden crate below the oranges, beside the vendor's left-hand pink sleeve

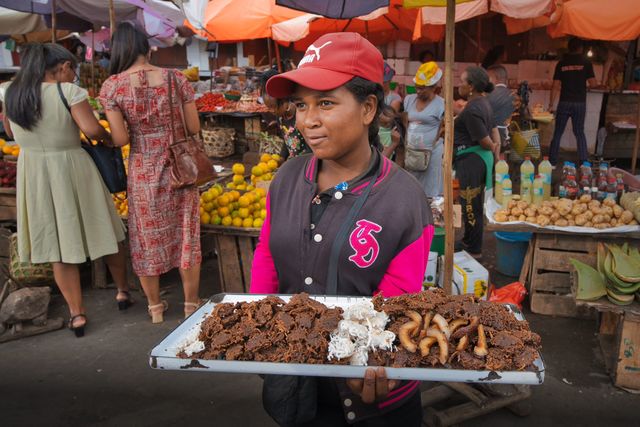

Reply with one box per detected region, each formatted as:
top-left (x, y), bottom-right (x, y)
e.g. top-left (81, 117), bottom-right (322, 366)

top-left (201, 225), bottom-right (260, 293)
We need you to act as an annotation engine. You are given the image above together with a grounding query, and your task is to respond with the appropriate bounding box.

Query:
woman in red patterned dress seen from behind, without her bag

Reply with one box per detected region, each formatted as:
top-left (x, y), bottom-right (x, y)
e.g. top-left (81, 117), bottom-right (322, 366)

top-left (100, 23), bottom-right (202, 323)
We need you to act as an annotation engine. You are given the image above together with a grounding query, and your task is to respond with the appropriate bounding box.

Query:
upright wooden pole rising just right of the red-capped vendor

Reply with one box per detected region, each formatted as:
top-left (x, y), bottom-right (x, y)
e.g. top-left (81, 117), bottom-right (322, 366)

top-left (442, 0), bottom-right (456, 294)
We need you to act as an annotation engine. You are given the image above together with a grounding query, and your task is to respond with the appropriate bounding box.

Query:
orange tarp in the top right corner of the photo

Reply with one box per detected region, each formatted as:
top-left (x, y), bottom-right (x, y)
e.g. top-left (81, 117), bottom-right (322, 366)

top-left (548, 0), bottom-right (640, 40)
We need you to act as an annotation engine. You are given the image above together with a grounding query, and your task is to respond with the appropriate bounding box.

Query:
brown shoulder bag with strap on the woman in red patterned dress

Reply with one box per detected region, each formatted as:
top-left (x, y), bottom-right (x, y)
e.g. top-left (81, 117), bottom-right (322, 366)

top-left (169, 70), bottom-right (215, 188)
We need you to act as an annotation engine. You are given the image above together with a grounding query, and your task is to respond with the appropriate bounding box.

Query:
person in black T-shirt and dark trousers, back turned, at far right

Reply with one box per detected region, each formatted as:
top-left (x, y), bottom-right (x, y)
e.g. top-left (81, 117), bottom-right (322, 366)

top-left (549, 38), bottom-right (597, 166)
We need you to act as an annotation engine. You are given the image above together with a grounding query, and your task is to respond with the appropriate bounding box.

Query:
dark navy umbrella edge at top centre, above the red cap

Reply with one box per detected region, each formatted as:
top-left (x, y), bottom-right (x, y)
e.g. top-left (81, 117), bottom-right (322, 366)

top-left (276, 0), bottom-right (389, 19)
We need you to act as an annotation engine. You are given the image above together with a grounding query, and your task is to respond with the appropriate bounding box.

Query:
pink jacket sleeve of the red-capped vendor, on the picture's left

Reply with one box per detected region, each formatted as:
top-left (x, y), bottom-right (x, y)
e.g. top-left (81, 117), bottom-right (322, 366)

top-left (249, 195), bottom-right (278, 294)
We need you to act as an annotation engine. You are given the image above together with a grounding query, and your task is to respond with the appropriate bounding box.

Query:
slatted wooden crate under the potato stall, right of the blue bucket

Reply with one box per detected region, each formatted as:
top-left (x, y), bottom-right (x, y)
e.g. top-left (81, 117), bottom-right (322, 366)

top-left (530, 234), bottom-right (596, 317)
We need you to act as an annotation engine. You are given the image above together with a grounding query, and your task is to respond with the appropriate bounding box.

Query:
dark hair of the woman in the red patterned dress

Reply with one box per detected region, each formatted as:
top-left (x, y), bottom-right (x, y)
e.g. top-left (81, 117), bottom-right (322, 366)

top-left (109, 22), bottom-right (149, 75)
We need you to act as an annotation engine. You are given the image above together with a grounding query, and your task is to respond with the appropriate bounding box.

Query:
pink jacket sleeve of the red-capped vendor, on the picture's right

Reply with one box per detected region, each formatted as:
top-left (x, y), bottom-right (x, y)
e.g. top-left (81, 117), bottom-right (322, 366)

top-left (376, 225), bottom-right (434, 297)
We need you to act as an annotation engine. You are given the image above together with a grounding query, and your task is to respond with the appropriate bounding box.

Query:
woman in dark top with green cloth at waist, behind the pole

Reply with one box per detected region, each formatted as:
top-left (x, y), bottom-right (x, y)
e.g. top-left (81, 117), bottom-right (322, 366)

top-left (453, 67), bottom-right (500, 258)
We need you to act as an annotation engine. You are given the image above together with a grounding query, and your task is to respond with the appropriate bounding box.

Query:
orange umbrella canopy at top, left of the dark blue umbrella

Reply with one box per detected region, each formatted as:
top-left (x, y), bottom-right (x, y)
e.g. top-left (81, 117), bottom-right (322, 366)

top-left (190, 0), bottom-right (304, 42)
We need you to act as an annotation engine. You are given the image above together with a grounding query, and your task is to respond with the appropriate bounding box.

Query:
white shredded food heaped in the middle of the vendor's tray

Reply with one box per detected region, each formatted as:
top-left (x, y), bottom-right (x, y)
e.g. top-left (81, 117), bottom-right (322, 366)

top-left (328, 300), bottom-right (396, 366)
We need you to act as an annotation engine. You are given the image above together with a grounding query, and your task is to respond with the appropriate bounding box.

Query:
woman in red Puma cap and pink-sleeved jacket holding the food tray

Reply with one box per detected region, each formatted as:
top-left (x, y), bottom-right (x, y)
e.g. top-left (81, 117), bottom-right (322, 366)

top-left (251, 33), bottom-right (433, 426)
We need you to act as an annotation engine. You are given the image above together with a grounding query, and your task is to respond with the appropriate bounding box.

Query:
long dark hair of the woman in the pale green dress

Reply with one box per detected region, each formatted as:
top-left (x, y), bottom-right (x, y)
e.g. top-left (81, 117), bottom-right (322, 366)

top-left (4, 43), bottom-right (78, 130)
